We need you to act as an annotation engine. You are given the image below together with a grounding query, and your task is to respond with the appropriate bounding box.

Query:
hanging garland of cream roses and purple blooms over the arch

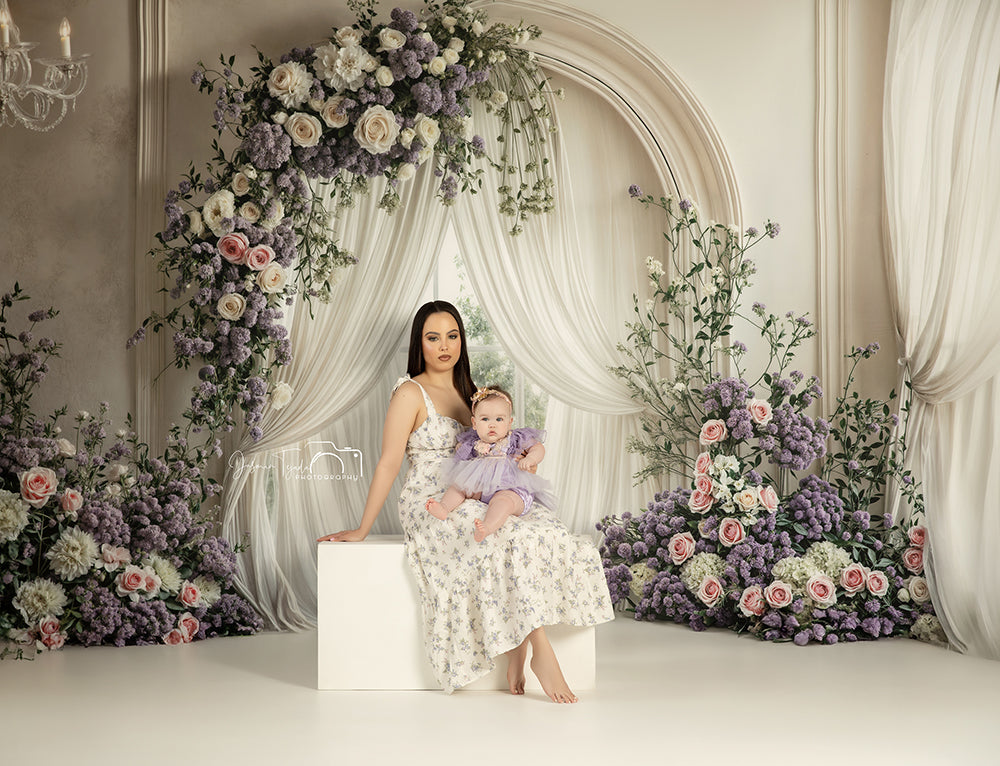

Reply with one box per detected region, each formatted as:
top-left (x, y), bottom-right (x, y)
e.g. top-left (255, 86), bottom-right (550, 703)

top-left (130, 0), bottom-right (552, 440)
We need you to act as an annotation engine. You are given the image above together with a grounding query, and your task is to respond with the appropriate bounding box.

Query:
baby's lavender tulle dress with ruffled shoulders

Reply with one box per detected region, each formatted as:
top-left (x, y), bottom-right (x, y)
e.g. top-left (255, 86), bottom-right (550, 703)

top-left (445, 428), bottom-right (556, 516)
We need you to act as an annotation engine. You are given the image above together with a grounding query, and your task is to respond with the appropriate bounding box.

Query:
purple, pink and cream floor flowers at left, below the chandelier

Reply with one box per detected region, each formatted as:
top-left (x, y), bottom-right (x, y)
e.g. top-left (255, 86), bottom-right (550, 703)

top-left (0, 285), bottom-right (261, 656)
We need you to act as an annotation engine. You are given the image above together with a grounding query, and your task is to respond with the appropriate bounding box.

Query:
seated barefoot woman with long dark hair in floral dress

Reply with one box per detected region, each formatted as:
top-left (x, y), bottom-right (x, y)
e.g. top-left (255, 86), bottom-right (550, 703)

top-left (319, 301), bottom-right (613, 702)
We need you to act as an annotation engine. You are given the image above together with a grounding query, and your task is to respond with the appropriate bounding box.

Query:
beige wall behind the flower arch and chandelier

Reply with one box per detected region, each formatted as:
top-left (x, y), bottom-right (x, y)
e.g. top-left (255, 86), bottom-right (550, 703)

top-left (0, 0), bottom-right (895, 448)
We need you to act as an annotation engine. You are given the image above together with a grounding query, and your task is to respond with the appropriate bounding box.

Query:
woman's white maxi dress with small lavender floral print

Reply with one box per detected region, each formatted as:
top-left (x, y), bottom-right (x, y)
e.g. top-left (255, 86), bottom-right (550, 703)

top-left (396, 378), bottom-right (613, 693)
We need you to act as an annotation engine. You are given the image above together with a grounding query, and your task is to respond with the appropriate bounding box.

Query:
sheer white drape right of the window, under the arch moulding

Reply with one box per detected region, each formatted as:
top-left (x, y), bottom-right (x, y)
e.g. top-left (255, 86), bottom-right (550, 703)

top-left (455, 76), bottom-right (663, 532)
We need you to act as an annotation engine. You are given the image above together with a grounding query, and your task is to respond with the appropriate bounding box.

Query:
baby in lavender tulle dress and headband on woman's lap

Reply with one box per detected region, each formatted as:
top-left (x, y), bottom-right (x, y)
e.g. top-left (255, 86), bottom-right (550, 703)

top-left (426, 386), bottom-right (555, 543)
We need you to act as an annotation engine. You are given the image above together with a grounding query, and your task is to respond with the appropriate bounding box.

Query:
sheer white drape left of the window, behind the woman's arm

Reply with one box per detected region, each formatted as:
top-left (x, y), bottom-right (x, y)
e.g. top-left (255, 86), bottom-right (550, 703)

top-left (222, 168), bottom-right (446, 628)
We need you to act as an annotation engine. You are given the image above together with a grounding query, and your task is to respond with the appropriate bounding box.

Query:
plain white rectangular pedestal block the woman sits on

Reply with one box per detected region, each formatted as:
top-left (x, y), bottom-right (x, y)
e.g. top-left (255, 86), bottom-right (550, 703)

top-left (317, 535), bottom-right (596, 691)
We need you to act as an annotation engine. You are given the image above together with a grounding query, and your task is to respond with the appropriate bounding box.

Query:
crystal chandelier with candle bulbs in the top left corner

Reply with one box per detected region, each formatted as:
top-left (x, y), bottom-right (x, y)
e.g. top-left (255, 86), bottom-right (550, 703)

top-left (0, 0), bottom-right (89, 131)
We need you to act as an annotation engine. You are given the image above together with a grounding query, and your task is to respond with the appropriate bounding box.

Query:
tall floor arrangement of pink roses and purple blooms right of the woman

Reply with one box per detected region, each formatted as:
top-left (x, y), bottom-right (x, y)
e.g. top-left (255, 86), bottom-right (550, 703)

top-left (598, 186), bottom-right (946, 645)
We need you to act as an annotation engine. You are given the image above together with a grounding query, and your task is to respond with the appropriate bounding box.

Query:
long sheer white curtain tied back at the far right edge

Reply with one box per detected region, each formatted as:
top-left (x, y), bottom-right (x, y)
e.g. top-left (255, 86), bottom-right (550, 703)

top-left (884, 0), bottom-right (1000, 659)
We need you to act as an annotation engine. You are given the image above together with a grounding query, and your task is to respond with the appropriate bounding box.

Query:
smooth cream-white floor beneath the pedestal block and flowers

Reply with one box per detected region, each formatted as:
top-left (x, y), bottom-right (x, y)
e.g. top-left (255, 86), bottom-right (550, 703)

top-left (0, 617), bottom-right (1000, 766)
